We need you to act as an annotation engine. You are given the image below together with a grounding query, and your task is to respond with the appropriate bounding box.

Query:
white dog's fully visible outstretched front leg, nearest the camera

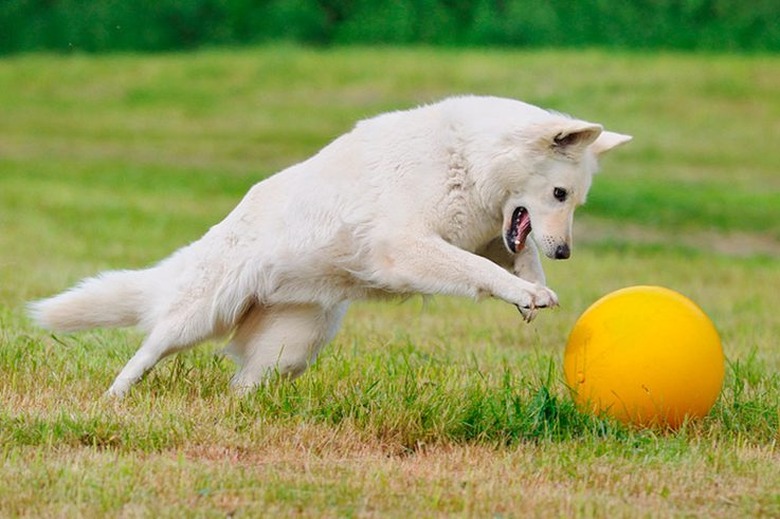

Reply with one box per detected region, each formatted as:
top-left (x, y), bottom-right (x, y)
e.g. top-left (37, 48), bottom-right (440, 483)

top-left (375, 235), bottom-right (558, 311)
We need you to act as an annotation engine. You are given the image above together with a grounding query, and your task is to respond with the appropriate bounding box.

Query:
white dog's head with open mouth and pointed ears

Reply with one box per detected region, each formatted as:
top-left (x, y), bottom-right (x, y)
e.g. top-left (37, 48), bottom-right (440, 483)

top-left (503, 121), bottom-right (631, 259)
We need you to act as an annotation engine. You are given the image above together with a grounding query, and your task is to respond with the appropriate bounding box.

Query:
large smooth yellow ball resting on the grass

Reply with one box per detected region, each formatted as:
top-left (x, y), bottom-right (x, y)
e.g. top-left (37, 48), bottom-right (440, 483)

top-left (563, 286), bottom-right (725, 428)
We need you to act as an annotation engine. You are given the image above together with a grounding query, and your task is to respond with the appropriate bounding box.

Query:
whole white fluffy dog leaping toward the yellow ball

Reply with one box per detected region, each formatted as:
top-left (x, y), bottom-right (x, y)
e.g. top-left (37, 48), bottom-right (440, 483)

top-left (30, 97), bottom-right (631, 396)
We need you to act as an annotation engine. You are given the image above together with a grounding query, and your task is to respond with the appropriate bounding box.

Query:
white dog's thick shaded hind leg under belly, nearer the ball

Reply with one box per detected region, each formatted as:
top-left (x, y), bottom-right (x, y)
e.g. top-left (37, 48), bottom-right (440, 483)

top-left (226, 302), bottom-right (348, 392)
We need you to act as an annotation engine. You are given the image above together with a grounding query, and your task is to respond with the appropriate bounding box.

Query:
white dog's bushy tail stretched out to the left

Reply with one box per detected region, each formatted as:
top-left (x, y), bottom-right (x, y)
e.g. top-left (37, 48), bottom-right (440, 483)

top-left (27, 270), bottom-right (151, 332)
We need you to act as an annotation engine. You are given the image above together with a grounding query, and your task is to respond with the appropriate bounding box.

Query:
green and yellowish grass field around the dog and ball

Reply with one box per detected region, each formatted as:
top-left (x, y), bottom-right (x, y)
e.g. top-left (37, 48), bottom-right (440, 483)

top-left (0, 47), bottom-right (780, 517)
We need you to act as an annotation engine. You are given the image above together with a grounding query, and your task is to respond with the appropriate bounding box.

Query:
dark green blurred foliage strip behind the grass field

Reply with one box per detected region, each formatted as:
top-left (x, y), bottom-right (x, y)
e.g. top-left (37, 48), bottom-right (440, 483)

top-left (0, 0), bottom-right (780, 54)
